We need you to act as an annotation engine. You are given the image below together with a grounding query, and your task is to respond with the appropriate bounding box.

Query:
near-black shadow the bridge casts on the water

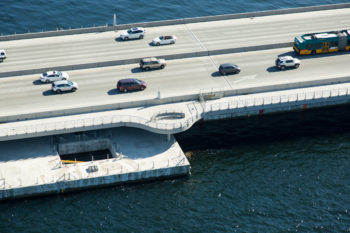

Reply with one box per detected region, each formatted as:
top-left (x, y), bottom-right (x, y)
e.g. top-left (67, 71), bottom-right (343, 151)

top-left (175, 105), bottom-right (350, 151)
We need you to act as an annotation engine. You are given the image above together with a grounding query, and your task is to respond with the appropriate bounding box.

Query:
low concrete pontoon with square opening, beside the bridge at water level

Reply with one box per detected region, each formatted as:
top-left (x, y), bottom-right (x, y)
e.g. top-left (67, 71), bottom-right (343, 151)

top-left (0, 127), bottom-right (190, 200)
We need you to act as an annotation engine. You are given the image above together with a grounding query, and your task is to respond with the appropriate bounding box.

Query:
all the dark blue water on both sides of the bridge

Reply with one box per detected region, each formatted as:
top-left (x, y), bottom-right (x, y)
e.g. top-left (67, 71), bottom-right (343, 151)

top-left (0, 0), bottom-right (350, 232)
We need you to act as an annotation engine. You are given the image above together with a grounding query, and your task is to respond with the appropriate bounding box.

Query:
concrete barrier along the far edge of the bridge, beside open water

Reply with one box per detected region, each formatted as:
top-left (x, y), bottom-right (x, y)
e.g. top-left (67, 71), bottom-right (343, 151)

top-left (0, 3), bottom-right (350, 41)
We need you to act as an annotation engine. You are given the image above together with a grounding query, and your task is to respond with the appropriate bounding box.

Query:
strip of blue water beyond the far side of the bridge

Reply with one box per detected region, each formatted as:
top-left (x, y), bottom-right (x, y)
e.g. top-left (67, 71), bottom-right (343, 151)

top-left (0, 0), bottom-right (349, 35)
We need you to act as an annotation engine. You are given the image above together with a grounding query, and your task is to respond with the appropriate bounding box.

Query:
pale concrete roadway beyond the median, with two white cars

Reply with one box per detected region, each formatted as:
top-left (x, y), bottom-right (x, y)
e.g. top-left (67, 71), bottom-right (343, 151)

top-left (0, 9), bottom-right (350, 72)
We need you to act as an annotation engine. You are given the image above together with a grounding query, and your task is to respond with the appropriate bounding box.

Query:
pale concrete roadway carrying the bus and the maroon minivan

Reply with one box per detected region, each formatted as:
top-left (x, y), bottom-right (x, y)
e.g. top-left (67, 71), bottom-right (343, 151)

top-left (0, 49), bottom-right (350, 119)
